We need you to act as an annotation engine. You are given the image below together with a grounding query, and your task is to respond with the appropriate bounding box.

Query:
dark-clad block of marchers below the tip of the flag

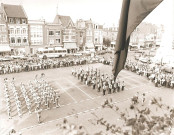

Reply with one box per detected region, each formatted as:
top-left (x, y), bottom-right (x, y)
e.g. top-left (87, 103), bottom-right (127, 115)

top-left (72, 67), bottom-right (125, 95)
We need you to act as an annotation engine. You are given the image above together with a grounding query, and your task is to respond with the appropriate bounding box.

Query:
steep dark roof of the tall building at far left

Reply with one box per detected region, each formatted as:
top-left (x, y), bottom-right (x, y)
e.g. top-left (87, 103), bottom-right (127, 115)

top-left (4, 4), bottom-right (27, 18)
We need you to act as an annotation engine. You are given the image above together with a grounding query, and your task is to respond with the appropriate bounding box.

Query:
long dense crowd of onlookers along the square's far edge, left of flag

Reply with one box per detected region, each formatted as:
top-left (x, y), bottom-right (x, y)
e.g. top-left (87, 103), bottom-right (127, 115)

top-left (0, 57), bottom-right (101, 75)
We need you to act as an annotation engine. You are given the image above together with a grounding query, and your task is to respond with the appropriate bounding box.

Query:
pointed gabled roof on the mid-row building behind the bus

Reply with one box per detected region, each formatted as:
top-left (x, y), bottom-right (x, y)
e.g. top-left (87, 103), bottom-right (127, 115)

top-left (53, 15), bottom-right (74, 27)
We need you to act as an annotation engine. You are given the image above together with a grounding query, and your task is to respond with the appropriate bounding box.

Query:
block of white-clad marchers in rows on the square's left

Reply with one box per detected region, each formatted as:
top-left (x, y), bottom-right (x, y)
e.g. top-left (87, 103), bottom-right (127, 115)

top-left (4, 74), bottom-right (60, 121)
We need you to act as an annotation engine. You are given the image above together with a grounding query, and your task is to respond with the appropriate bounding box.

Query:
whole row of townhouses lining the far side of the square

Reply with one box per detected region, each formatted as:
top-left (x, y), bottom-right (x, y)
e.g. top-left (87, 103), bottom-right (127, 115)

top-left (0, 3), bottom-right (162, 54)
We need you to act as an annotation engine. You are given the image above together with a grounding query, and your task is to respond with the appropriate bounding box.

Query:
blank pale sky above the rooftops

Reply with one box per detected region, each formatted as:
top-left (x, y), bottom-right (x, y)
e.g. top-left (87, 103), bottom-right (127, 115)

top-left (0, 0), bottom-right (174, 27)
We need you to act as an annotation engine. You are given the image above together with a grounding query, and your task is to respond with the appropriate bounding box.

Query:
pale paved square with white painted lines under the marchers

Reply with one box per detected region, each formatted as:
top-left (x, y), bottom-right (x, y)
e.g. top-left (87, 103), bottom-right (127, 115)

top-left (0, 64), bottom-right (174, 135)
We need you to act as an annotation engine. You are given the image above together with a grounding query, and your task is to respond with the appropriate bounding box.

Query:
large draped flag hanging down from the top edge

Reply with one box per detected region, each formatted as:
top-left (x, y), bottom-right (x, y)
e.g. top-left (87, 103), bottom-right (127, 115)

top-left (112, 0), bottom-right (163, 79)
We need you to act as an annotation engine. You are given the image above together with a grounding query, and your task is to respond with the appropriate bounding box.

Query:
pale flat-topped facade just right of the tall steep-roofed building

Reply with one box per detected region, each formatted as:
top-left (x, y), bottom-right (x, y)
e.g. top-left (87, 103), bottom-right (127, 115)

top-left (28, 20), bottom-right (46, 54)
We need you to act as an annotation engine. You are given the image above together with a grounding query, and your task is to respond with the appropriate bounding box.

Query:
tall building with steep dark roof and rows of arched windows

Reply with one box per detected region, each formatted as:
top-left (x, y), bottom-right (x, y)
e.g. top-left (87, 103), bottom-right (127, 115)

top-left (2, 4), bottom-right (29, 54)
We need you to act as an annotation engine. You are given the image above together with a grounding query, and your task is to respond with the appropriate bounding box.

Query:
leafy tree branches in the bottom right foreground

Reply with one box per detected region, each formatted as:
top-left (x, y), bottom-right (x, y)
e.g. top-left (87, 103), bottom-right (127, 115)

top-left (58, 94), bottom-right (174, 135)
